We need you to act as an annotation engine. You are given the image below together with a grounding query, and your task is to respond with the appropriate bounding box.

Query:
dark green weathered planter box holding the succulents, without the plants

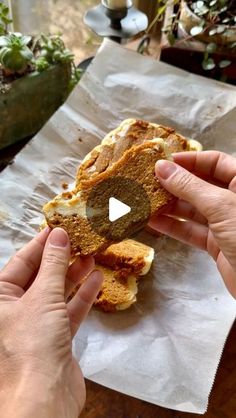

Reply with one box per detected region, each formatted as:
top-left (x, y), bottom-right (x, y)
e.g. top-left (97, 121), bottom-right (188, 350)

top-left (0, 64), bottom-right (71, 149)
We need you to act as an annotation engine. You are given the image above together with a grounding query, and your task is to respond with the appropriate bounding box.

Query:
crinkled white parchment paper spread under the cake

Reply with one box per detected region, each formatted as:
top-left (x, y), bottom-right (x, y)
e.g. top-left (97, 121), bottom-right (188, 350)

top-left (0, 41), bottom-right (236, 413)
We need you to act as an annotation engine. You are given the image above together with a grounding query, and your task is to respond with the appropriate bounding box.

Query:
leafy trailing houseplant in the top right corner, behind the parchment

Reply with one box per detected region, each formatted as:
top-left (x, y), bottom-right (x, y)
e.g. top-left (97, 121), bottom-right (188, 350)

top-left (153, 0), bottom-right (236, 71)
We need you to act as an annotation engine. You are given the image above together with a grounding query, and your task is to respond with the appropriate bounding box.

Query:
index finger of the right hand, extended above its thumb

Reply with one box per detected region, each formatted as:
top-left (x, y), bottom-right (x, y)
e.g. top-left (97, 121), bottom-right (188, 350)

top-left (173, 151), bottom-right (236, 184)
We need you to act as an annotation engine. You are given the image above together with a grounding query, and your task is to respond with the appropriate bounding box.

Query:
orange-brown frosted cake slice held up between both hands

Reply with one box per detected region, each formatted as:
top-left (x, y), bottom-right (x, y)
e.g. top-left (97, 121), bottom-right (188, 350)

top-left (43, 139), bottom-right (173, 255)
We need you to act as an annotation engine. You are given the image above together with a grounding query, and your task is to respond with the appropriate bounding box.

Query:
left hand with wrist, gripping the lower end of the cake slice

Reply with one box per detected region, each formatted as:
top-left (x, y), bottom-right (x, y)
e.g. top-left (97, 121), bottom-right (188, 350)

top-left (0, 228), bottom-right (103, 418)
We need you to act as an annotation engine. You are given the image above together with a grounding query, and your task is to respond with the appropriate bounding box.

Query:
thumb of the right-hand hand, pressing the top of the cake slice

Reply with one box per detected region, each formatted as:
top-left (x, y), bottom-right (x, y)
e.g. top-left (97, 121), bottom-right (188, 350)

top-left (155, 160), bottom-right (236, 223)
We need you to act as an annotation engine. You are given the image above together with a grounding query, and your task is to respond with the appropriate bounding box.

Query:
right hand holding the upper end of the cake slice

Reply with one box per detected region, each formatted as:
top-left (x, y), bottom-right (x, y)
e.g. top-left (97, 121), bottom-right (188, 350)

top-left (150, 151), bottom-right (236, 297)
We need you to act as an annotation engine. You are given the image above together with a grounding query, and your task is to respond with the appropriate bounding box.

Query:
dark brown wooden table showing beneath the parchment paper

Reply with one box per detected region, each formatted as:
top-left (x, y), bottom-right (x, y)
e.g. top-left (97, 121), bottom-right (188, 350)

top-left (0, 140), bottom-right (236, 418)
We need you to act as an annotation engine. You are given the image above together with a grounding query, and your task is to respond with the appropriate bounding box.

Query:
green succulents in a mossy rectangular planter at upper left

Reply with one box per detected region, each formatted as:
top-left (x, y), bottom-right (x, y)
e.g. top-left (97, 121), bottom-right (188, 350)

top-left (0, 3), bottom-right (80, 149)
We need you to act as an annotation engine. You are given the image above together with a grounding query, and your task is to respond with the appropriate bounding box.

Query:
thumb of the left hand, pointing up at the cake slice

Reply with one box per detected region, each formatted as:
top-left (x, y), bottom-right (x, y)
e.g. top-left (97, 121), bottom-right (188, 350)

top-left (33, 228), bottom-right (70, 300)
